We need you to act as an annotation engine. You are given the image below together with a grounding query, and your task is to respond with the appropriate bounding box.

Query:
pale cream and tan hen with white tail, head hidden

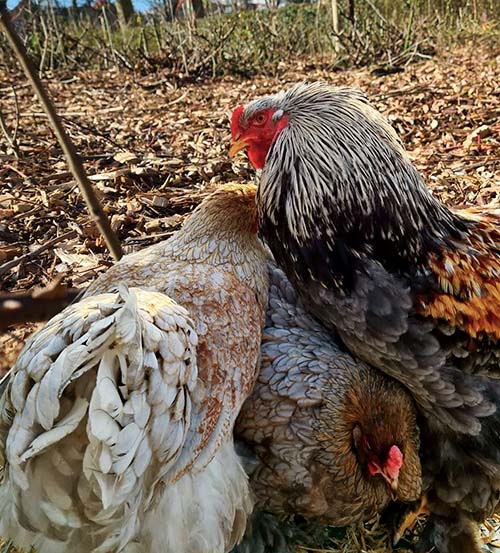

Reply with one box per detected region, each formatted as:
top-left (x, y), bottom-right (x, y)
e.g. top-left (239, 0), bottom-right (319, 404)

top-left (0, 185), bottom-right (269, 553)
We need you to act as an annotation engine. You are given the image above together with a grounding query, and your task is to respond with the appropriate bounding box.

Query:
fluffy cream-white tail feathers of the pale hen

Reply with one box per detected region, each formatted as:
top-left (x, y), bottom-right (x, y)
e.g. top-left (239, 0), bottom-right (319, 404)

top-left (0, 289), bottom-right (199, 551)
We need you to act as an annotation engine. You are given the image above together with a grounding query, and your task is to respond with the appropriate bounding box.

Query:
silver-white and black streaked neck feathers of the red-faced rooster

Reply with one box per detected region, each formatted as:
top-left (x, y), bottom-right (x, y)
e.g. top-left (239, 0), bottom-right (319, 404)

top-left (258, 86), bottom-right (474, 288)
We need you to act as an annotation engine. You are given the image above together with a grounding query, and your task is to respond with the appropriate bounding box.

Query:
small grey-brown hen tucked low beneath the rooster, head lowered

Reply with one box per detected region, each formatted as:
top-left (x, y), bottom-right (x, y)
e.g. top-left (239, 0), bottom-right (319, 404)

top-left (235, 265), bottom-right (421, 551)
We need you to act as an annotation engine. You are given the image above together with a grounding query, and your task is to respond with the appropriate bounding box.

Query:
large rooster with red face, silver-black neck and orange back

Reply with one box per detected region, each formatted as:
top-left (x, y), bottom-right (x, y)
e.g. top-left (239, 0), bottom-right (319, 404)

top-left (230, 83), bottom-right (500, 553)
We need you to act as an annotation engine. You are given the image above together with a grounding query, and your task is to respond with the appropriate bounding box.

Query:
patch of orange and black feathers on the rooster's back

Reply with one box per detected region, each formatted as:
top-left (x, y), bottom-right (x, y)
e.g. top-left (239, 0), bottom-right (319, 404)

top-left (415, 209), bottom-right (500, 348)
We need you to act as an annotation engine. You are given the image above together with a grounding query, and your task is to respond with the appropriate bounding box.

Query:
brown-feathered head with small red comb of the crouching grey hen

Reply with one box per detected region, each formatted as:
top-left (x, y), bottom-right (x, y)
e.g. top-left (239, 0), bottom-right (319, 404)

top-left (323, 364), bottom-right (421, 501)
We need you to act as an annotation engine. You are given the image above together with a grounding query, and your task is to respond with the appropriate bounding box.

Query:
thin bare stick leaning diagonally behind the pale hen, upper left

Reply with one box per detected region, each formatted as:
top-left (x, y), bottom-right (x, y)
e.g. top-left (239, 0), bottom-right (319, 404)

top-left (0, 5), bottom-right (123, 261)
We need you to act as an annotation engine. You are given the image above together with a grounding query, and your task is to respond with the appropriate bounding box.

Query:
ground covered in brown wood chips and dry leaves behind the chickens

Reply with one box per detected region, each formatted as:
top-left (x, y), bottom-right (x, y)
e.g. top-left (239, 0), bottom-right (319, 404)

top-left (0, 37), bottom-right (500, 553)
